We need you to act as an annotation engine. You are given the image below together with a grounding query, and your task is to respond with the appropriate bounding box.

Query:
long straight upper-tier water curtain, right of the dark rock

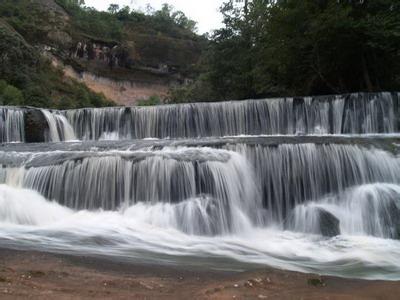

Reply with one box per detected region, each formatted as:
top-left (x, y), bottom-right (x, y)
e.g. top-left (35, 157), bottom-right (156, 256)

top-left (64, 93), bottom-right (398, 140)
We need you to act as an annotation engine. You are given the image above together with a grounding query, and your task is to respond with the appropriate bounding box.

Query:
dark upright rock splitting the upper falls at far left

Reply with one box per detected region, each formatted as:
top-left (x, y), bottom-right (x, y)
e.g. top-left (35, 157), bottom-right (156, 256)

top-left (24, 108), bottom-right (49, 143)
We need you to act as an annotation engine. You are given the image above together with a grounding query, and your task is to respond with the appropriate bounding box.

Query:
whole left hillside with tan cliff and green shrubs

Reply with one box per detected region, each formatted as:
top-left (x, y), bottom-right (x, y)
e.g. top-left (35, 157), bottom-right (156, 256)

top-left (0, 0), bottom-right (205, 108)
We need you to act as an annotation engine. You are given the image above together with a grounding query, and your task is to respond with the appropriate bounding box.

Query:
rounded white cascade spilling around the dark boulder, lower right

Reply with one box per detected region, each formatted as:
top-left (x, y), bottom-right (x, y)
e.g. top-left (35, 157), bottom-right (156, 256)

top-left (290, 183), bottom-right (400, 239)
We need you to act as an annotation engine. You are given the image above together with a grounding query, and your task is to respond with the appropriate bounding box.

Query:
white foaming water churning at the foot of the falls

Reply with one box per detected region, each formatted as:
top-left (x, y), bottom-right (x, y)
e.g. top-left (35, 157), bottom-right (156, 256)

top-left (0, 185), bottom-right (400, 280)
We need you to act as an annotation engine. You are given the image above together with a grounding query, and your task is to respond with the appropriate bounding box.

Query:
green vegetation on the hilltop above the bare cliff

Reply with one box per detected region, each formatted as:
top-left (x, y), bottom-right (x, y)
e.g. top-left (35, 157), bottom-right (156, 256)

top-left (56, 0), bottom-right (206, 81)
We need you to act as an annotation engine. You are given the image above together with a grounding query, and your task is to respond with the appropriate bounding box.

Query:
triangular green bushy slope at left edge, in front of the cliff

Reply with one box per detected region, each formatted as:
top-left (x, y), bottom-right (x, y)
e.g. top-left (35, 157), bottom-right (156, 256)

top-left (0, 22), bottom-right (112, 108)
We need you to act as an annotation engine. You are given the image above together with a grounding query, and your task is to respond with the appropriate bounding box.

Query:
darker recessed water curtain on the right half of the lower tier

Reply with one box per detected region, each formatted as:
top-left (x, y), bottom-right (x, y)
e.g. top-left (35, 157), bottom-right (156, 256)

top-left (229, 144), bottom-right (400, 223)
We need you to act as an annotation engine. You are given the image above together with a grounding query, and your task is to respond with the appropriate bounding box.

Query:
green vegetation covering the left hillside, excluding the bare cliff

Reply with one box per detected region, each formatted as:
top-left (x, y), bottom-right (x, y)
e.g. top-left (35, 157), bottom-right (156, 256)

top-left (0, 0), bottom-right (199, 108)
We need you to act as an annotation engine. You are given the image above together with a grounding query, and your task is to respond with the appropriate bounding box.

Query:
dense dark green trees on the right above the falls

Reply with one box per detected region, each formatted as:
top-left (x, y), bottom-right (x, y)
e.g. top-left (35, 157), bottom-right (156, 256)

top-left (171, 0), bottom-right (400, 102)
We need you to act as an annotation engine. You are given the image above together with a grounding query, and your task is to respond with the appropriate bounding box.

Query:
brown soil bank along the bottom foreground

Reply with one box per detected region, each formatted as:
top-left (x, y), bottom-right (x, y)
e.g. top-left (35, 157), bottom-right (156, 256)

top-left (0, 250), bottom-right (400, 300)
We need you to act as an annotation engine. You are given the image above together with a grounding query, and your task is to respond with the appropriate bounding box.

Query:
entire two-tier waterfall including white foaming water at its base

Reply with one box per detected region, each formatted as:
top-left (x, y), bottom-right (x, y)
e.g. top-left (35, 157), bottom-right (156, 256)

top-left (0, 93), bottom-right (400, 280)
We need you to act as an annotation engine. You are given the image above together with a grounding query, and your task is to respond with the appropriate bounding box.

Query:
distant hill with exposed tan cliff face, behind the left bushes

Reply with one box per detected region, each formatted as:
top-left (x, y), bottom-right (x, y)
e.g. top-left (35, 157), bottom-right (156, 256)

top-left (0, 0), bottom-right (204, 105)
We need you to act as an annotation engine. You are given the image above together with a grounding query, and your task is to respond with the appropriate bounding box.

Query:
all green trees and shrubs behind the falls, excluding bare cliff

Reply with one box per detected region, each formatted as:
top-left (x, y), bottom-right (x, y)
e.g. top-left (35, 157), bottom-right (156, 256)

top-left (0, 0), bottom-right (400, 108)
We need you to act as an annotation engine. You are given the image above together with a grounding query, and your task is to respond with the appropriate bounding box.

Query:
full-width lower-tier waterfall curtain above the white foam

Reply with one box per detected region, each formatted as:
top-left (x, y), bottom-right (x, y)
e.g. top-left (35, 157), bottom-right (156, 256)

top-left (0, 144), bottom-right (400, 232)
